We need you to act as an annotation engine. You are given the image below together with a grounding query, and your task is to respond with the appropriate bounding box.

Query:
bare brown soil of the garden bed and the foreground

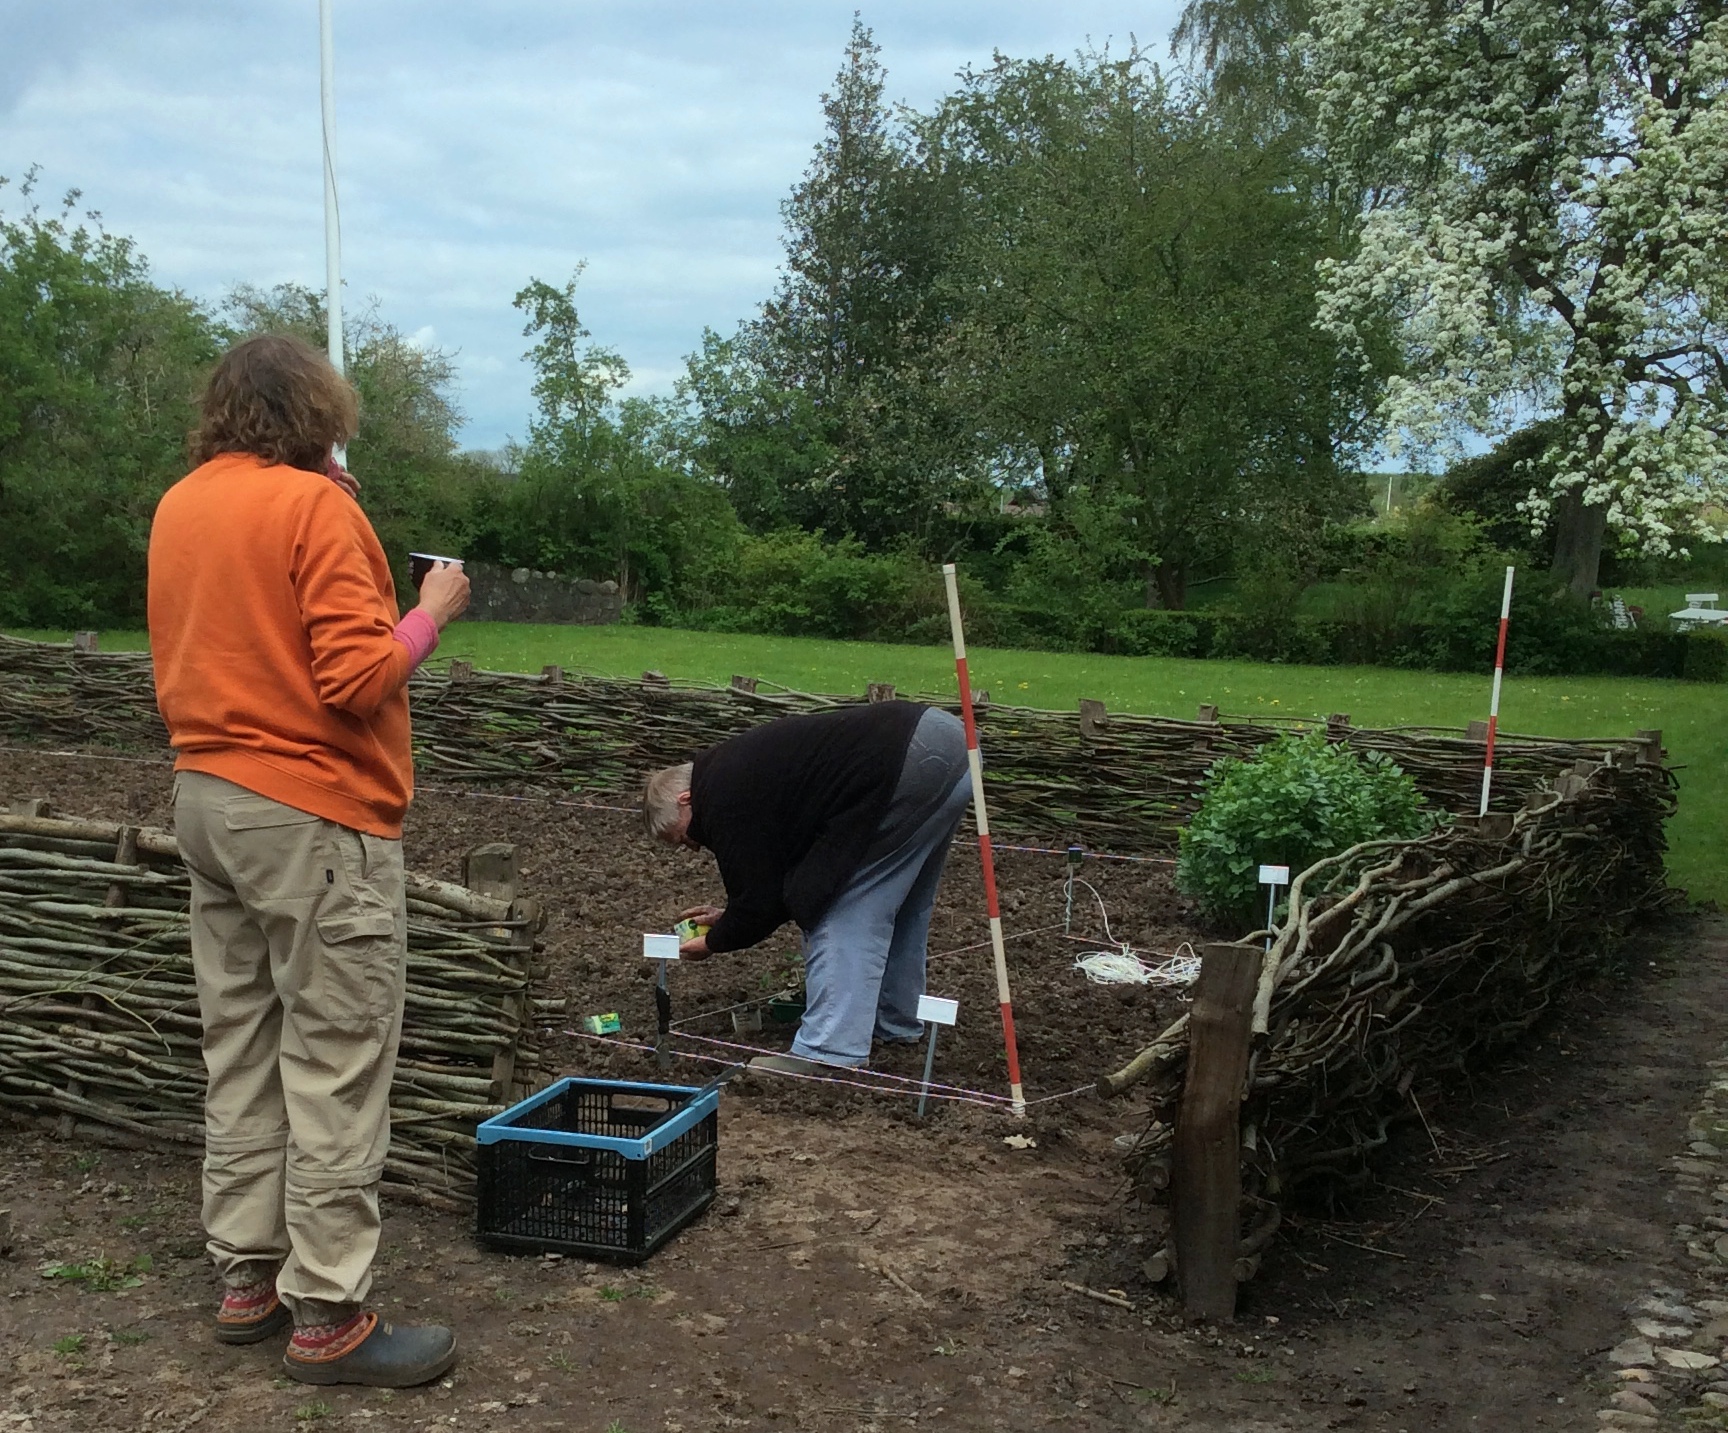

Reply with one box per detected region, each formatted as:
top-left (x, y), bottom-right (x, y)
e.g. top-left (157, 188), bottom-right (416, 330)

top-left (0, 752), bottom-right (1728, 1433)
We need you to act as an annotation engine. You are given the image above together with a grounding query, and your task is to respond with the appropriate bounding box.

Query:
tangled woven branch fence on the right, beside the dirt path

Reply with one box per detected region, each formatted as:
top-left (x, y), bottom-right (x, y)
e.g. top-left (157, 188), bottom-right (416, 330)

top-left (1099, 743), bottom-right (1674, 1244)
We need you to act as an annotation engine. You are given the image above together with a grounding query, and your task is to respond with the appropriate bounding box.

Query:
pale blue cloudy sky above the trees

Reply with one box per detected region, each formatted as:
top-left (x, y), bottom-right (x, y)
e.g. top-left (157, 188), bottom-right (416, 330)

top-left (0, 0), bottom-right (1180, 448)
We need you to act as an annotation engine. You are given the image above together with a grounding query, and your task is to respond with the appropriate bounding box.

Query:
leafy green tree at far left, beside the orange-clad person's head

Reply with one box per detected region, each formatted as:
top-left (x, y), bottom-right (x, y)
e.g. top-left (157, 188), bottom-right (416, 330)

top-left (0, 171), bottom-right (218, 626)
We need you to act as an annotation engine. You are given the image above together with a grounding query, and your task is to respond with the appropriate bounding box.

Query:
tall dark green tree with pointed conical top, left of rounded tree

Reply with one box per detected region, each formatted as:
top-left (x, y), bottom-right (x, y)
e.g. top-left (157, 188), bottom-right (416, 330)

top-left (684, 22), bottom-right (973, 550)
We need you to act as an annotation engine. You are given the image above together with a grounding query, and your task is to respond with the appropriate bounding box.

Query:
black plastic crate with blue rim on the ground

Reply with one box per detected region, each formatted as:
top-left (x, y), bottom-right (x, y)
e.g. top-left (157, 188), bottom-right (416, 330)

top-left (475, 1079), bottom-right (721, 1264)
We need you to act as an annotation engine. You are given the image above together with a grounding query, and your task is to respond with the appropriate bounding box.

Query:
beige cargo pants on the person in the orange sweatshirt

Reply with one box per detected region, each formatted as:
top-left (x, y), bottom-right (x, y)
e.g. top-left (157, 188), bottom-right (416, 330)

top-left (175, 771), bottom-right (408, 1324)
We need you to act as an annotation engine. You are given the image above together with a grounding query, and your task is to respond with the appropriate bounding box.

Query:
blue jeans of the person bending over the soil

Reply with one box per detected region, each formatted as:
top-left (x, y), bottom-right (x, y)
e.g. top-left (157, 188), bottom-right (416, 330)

top-left (791, 710), bottom-right (971, 1065)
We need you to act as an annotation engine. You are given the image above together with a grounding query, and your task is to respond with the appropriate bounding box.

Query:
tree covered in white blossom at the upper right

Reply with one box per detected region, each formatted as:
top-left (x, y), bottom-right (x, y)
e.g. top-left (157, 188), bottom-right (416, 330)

top-left (1299, 0), bottom-right (1728, 593)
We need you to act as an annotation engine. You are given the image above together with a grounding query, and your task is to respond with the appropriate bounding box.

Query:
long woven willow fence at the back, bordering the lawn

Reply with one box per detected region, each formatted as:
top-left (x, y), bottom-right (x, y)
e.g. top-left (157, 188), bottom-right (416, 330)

top-left (0, 638), bottom-right (1651, 852)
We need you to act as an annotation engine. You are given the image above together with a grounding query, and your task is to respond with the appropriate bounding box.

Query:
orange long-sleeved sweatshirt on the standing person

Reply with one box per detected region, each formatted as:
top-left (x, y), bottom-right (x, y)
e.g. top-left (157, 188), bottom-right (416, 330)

top-left (150, 453), bottom-right (413, 838)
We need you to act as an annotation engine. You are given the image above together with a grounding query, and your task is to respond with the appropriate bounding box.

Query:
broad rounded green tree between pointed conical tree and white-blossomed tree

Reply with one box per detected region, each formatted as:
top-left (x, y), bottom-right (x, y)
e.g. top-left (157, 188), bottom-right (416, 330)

top-left (926, 54), bottom-right (1372, 608)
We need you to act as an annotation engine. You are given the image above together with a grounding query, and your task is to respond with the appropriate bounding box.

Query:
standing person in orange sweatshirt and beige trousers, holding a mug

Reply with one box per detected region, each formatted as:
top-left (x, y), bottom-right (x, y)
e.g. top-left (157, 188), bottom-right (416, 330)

top-left (149, 335), bottom-right (468, 1386)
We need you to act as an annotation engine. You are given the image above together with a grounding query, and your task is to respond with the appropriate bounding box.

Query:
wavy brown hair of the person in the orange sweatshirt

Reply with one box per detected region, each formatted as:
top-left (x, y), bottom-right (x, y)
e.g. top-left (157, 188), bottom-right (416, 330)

top-left (190, 334), bottom-right (359, 472)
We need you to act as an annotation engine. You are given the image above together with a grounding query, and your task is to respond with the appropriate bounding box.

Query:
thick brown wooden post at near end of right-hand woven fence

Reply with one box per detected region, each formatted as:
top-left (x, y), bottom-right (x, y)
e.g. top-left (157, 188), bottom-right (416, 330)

top-left (1170, 946), bottom-right (1263, 1319)
